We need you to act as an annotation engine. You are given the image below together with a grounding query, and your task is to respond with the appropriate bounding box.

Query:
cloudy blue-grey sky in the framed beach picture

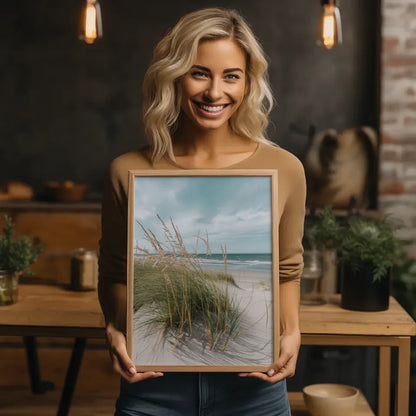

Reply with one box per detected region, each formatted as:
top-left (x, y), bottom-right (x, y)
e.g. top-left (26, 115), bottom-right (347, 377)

top-left (134, 176), bottom-right (271, 254)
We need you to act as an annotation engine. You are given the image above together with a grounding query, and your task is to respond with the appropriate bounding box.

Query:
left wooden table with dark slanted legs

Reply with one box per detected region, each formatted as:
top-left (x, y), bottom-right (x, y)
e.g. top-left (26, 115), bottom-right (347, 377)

top-left (0, 284), bottom-right (105, 416)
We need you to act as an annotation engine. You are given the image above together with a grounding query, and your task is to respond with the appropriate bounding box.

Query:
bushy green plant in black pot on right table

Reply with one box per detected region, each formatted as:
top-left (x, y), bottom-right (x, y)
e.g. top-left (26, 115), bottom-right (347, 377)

top-left (314, 207), bottom-right (404, 311)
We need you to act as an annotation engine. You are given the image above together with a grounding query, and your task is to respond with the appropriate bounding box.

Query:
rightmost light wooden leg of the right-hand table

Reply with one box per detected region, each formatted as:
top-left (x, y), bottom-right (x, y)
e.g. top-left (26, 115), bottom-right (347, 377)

top-left (395, 337), bottom-right (410, 416)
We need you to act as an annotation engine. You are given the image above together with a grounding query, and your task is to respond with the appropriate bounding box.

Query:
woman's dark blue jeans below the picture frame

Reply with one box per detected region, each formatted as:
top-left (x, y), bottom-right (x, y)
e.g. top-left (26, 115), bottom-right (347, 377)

top-left (115, 373), bottom-right (290, 416)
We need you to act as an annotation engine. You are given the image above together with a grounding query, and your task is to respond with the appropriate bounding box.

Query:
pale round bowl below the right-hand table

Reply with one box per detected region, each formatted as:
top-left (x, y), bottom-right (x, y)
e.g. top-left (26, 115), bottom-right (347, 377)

top-left (303, 384), bottom-right (359, 416)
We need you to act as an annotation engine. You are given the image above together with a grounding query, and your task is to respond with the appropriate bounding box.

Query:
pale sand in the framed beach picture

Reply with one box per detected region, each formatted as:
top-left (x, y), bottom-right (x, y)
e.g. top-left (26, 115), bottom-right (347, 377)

top-left (132, 270), bottom-right (273, 366)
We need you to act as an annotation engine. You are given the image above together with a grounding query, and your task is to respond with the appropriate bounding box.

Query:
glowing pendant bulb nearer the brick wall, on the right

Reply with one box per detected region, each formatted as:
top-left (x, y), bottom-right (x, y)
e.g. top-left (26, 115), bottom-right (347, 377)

top-left (318, 0), bottom-right (342, 49)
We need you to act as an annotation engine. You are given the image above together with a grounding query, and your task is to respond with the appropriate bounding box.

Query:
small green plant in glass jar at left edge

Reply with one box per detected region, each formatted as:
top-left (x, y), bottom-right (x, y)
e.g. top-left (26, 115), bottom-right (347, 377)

top-left (0, 215), bottom-right (43, 306)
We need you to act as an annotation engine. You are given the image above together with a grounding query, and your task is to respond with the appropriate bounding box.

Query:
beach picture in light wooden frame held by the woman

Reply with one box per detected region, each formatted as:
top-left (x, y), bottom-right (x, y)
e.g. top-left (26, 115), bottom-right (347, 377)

top-left (127, 169), bottom-right (279, 371)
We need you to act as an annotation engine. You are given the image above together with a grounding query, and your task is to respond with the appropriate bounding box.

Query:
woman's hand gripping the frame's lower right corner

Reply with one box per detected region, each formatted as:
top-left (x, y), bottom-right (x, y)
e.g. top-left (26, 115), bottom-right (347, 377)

top-left (239, 332), bottom-right (300, 383)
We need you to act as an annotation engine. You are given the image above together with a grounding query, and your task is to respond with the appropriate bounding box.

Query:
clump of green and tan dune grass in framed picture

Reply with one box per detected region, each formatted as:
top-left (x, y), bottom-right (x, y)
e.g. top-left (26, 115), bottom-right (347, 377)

top-left (134, 216), bottom-right (241, 350)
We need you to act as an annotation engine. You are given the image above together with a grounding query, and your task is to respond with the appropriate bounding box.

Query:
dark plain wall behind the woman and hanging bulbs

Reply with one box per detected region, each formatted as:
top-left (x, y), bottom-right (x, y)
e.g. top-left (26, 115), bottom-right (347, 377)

top-left (0, 0), bottom-right (378, 192)
